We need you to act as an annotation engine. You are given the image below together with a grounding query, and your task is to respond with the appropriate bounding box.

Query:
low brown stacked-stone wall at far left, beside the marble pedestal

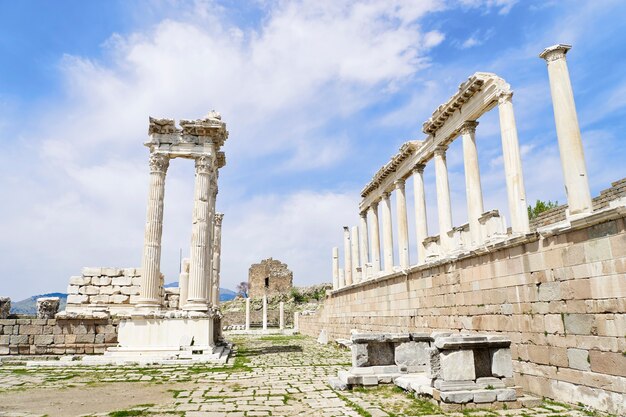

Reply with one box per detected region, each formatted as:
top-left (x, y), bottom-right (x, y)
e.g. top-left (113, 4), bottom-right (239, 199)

top-left (0, 319), bottom-right (119, 355)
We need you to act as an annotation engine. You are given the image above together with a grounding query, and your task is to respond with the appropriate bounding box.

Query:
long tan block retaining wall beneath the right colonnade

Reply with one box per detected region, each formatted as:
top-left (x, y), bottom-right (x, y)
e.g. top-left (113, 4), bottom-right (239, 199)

top-left (299, 207), bottom-right (626, 415)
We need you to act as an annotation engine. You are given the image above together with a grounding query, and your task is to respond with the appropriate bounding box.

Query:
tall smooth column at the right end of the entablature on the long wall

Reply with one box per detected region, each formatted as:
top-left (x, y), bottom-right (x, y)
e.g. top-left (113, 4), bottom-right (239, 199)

top-left (498, 92), bottom-right (530, 233)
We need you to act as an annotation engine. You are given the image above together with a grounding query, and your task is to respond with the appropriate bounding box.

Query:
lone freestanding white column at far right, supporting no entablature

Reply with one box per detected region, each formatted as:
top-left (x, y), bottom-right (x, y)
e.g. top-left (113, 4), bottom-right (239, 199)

top-left (539, 44), bottom-right (593, 214)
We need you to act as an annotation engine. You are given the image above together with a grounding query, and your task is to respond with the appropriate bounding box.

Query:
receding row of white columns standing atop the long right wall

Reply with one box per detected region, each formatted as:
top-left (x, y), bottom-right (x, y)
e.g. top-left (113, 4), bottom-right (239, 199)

top-left (333, 45), bottom-right (592, 288)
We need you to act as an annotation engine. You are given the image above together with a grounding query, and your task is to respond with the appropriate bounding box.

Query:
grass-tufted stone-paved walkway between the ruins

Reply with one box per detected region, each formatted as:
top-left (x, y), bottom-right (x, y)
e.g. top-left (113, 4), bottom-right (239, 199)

top-left (0, 335), bottom-right (600, 417)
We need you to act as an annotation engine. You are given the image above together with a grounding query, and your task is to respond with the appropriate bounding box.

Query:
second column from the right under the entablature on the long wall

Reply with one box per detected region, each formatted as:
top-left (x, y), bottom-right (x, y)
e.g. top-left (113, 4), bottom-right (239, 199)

top-left (461, 121), bottom-right (484, 245)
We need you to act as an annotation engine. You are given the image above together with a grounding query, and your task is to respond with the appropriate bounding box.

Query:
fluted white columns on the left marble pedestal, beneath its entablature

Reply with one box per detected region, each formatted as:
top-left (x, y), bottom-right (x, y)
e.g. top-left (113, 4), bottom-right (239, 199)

top-left (136, 153), bottom-right (223, 311)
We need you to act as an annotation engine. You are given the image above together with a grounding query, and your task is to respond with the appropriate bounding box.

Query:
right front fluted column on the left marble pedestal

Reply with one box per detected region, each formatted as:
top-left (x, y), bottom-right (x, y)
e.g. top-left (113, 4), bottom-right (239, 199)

top-left (184, 156), bottom-right (213, 311)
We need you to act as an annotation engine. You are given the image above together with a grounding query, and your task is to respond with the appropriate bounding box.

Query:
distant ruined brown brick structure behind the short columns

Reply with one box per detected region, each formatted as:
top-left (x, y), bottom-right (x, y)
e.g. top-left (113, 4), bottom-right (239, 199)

top-left (248, 258), bottom-right (293, 298)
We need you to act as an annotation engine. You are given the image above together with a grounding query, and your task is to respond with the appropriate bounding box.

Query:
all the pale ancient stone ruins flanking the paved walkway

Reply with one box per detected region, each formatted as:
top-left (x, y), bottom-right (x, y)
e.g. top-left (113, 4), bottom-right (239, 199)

top-left (0, 45), bottom-right (626, 415)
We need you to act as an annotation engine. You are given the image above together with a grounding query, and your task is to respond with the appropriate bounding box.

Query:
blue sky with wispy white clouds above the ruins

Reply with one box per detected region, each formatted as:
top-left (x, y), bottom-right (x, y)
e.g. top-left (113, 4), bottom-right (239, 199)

top-left (0, 0), bottom-right (626, 299)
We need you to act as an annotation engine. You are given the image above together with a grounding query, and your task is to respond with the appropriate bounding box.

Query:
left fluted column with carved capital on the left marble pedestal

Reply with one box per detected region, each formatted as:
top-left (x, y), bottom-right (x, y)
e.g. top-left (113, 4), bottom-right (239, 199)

top-left (137, 153), bottom-right (170, 309)
